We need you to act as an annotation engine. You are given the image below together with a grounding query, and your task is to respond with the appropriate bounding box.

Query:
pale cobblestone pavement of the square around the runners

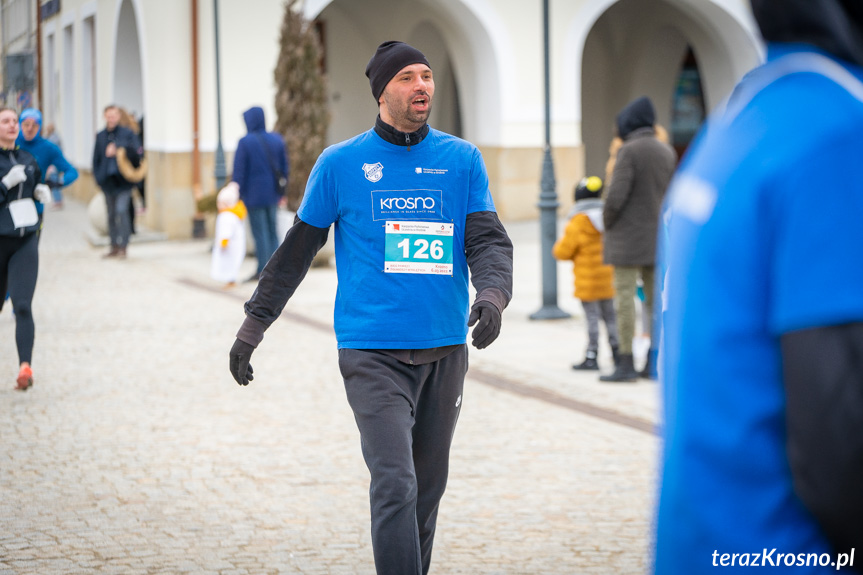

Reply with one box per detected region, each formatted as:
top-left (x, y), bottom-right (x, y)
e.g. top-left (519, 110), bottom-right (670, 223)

top-left (0, 202), bottom-right (659, 575)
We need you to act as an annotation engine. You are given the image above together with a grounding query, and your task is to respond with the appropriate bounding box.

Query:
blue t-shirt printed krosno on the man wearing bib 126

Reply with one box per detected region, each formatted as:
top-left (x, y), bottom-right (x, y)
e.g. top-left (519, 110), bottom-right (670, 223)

top-left (298, 130), bottom-right (494, 349)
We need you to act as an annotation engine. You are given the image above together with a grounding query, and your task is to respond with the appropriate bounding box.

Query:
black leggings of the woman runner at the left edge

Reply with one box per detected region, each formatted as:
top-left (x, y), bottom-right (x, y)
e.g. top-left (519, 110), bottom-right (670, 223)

top-left (0, 232), bottom-right (39, 363)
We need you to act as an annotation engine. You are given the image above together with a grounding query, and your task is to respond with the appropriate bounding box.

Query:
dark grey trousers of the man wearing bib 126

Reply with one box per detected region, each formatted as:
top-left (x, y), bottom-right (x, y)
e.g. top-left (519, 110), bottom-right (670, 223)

top-left (339, 345), bottom-right (468, 575)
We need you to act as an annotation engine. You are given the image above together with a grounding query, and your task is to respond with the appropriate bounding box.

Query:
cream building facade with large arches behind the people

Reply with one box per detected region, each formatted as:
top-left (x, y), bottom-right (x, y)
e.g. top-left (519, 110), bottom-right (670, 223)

top-left (25, 0), bottom-right (763, 237)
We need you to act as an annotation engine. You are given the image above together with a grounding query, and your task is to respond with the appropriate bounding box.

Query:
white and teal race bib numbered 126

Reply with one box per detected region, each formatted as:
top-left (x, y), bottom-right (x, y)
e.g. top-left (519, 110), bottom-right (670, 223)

top-left (384, 222), bottom-right (454, 276)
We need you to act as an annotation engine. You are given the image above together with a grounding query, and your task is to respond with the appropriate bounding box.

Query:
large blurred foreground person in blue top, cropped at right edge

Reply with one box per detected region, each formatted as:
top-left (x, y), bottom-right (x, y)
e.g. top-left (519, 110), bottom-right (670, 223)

top-left (655, 0), bottom-right (863, 575)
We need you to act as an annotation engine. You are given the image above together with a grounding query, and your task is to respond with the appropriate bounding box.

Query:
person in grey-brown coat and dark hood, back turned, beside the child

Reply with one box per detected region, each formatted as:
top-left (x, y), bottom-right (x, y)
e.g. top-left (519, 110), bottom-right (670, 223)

top-left (600, 96), bottom-right (677, 382)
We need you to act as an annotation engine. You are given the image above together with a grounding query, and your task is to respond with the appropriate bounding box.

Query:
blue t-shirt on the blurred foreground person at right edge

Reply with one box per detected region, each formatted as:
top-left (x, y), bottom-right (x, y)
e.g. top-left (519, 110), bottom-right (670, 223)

top-left (655, 46), bottom-right (863, 574)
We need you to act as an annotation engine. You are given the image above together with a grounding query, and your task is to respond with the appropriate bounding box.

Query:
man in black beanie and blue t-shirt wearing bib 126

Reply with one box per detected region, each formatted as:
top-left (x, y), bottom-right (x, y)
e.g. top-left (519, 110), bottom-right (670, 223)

top-left (230, 41), bottom-right (512, 575)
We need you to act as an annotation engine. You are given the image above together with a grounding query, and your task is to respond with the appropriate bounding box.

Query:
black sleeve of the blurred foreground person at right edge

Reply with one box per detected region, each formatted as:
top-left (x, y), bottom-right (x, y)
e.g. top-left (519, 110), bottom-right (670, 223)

top-left (782, 323), bottom-right (863, 553)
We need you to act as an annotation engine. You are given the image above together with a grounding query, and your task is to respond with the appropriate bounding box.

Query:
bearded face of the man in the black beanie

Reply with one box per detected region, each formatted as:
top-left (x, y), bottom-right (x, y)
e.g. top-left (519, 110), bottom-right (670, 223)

top-left (380, 64), bottom-right (434, 132)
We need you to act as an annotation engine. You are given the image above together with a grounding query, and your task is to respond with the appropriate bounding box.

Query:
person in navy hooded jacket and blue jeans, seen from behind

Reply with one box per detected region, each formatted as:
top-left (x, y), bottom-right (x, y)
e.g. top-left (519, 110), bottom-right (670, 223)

top-left (231, 106), bottom-right (289, 280)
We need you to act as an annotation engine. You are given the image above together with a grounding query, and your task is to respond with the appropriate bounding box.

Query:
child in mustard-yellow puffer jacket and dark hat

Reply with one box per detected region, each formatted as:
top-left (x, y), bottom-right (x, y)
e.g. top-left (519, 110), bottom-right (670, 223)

top-left (553, 176), bottom-right (618, 370)
